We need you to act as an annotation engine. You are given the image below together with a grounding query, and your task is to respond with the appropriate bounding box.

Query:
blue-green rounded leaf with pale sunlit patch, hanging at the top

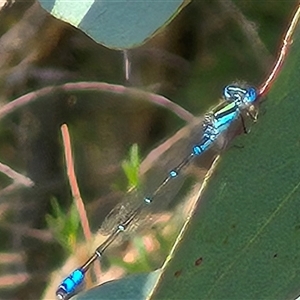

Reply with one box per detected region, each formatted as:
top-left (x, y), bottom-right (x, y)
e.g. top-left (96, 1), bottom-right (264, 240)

top-left (40, 0), bottom-right (188, 49)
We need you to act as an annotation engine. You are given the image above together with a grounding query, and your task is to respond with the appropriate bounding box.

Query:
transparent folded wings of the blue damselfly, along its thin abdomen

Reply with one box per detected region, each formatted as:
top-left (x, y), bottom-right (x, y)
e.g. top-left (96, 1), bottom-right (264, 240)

top-left (100, 118), bottom-right (218, 234)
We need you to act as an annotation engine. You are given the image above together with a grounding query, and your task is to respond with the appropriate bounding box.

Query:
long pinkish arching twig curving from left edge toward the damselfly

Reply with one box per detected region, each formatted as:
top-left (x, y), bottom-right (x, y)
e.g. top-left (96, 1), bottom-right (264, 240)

top-left (0, 81), bottom-right (194, 122)
